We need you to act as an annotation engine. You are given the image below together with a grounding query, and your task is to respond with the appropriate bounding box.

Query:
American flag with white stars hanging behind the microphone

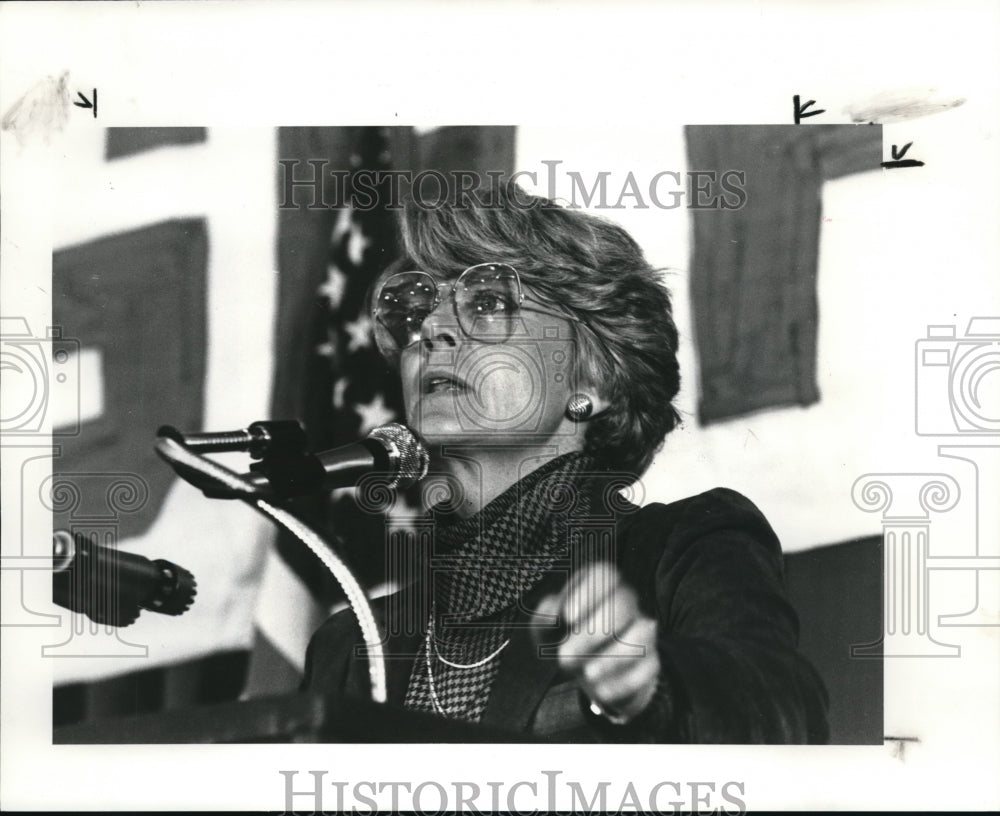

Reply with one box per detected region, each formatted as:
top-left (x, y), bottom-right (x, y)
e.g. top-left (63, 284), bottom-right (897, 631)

top-left (248, 127), bottom-right (416, 696)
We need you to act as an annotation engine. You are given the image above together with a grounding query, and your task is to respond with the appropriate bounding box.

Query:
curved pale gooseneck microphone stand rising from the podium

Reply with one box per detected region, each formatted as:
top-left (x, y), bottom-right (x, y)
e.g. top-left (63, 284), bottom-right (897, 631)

top-left (156, 430), bottom-right (387, 703)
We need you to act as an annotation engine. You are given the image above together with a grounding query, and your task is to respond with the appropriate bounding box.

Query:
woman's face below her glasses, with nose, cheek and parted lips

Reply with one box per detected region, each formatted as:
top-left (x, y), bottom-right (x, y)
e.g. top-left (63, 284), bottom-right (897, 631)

top-left (400, 278), bottom-right (579, 449)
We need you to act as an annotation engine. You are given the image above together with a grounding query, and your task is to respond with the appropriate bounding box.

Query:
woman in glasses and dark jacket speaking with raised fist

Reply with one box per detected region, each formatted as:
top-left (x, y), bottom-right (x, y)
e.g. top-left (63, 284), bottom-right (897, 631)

top-left (305, 185), bottom-right (827, 743)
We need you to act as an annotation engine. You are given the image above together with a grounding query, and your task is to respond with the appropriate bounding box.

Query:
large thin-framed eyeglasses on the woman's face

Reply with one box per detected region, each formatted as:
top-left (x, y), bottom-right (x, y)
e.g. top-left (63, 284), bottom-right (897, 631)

top-left (372, 263), bottom-right (580, 360)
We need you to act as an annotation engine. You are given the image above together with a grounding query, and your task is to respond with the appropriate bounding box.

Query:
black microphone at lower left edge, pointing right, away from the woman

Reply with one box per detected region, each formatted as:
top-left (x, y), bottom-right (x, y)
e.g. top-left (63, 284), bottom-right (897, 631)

top-left (52, 530), bottom-right (197, 626)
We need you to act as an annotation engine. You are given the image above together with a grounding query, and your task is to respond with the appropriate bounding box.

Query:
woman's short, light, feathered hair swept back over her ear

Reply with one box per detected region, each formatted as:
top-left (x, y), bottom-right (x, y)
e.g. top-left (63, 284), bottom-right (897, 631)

top-left (372, 183), bottom-right (680, 476)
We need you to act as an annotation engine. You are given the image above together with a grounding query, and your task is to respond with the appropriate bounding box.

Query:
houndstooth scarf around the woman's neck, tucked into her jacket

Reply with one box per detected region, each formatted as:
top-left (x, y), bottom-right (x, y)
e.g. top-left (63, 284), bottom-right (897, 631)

top-left (404, 453), bottom-right (595, 722)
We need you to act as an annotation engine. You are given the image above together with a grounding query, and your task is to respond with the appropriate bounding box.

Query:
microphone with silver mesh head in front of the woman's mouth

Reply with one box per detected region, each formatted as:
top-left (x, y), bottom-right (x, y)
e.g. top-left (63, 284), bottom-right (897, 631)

top-left (211, 422), bottom-right (430, 499)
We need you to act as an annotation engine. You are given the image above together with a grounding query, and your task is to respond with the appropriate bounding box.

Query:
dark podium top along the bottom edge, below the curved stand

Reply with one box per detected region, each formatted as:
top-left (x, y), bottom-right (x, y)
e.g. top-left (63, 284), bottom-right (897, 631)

top-left (52, 693), bottom-right (545, 745)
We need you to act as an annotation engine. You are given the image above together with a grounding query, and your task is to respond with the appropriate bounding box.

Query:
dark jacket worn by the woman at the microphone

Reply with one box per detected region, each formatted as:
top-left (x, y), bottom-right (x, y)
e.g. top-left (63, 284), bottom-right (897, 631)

top-left (303, 489), bottom-right (828, 743)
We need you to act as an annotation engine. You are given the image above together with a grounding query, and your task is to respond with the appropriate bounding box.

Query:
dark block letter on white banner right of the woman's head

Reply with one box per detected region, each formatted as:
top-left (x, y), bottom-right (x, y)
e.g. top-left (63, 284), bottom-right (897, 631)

top-left (685, 125), bottom-right (882, 423)
